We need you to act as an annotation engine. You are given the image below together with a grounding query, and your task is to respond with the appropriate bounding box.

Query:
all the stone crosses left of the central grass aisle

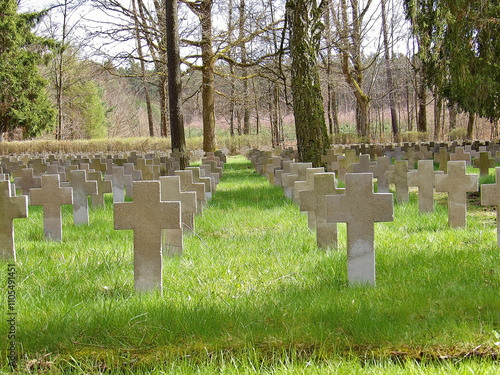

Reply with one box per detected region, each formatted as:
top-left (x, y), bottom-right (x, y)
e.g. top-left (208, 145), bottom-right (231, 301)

top-left (0, 150), bottom-right (226, 291)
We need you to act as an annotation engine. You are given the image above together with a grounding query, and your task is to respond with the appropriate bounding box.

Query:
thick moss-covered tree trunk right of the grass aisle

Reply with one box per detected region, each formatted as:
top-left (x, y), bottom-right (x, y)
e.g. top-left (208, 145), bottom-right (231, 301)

top-left (287, 0), bottom-right (329, 167)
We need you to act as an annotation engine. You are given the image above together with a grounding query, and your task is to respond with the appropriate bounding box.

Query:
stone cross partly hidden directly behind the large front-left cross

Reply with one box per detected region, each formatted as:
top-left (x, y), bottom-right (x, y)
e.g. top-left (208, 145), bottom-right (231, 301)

top-left (160, 176), bottom-right (196, 256)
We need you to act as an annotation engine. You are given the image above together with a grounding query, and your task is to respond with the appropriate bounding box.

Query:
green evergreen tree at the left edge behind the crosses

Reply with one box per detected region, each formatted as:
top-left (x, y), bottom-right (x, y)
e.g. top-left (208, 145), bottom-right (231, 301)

top-left (0, 0), bottom-right (56, 137)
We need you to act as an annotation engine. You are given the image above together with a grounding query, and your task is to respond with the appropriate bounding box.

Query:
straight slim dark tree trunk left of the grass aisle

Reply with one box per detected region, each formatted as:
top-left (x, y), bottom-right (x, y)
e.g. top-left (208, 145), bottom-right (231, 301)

top-left (165, 0), bottom-right (188, 169)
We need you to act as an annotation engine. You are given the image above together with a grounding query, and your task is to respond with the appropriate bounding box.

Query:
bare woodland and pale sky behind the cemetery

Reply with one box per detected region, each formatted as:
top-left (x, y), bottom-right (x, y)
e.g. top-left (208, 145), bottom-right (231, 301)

top-left (0, 0), bottom-right (500, 150)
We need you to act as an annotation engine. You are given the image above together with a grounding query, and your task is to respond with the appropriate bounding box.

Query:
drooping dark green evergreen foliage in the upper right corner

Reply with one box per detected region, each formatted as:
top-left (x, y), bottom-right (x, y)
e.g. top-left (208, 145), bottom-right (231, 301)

top-left (405, 0), bottom-right (500, 119)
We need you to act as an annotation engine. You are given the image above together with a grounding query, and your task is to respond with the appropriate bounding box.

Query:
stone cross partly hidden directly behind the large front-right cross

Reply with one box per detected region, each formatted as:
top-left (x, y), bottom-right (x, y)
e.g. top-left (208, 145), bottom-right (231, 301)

top-left (300, 172), bottom-right (345, 249)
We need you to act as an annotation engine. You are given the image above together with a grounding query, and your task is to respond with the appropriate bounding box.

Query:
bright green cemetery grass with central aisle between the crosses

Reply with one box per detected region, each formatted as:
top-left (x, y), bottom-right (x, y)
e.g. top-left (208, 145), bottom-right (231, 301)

top-left (0, 156), bottom-right (500, 374)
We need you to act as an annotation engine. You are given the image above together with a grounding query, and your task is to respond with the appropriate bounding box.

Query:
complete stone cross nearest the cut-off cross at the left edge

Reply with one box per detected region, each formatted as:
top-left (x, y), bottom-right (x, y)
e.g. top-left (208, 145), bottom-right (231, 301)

top-left (31, 174), bottom-right (73, 241)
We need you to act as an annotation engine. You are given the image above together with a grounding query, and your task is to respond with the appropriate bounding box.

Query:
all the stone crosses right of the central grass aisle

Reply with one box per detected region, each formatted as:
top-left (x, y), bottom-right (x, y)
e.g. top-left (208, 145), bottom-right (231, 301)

top-left (247, 142), bottom-right (500, 284)
